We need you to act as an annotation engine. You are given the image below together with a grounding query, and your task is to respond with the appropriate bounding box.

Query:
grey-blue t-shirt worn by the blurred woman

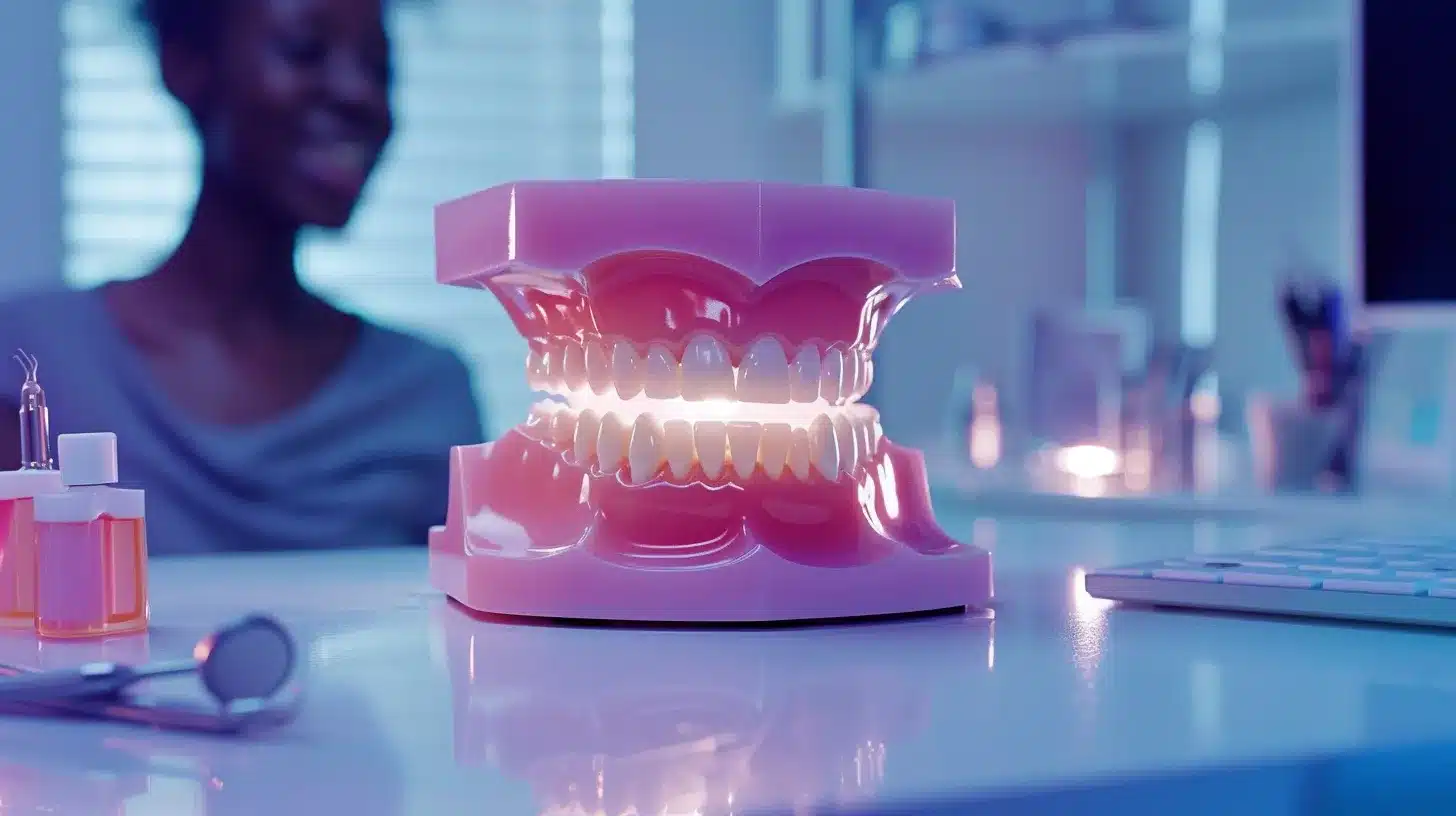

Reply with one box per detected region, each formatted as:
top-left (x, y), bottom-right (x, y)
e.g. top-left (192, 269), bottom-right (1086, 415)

top-left (0, 290), bottom-right (482, 554)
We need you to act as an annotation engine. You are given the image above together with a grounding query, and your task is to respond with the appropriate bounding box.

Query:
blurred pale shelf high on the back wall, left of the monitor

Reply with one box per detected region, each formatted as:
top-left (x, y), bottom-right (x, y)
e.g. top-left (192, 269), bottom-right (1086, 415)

top-left (778, 17), bottom-right (1348, 125)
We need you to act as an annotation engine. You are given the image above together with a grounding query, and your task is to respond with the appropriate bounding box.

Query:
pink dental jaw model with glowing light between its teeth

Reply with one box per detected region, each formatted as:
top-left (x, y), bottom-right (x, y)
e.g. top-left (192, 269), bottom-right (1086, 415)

top-left (430, 181), bottom-right (992, 622)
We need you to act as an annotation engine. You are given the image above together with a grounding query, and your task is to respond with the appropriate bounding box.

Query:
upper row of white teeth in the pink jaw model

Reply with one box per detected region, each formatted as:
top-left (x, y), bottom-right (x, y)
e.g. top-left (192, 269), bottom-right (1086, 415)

top-left (526, 335), bottom-right (874, 405)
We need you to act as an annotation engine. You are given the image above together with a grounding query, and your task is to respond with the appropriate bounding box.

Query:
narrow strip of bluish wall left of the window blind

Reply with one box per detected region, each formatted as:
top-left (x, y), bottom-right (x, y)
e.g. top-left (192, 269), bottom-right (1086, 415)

top-left (0, 1), bottom-right (61, 296)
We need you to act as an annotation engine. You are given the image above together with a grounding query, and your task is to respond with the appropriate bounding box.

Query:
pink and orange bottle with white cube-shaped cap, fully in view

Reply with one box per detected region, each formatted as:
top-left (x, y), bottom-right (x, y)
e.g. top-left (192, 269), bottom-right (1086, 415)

top-left (35, 433), bottom-right (149, 638)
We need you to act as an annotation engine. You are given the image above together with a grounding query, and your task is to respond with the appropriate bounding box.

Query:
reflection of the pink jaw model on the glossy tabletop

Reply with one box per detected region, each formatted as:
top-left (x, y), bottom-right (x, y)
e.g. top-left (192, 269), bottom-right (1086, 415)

top-left (434, 603), bottom-right (993, 816)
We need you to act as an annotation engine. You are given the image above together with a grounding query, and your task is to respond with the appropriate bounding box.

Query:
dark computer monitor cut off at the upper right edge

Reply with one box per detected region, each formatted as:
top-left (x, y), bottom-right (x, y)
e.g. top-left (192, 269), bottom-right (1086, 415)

top-left (1344, 0), bottom-right (1456, 328)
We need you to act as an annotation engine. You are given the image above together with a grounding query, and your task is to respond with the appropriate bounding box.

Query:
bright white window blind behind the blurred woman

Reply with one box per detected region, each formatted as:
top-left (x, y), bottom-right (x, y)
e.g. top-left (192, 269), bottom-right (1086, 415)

top-left (61, 0), bottom-right (633, 433)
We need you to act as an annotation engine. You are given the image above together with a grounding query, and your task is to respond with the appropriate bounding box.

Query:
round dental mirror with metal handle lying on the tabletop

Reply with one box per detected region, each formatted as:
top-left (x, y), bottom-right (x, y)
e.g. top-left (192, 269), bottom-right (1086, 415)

top-left (0, 615), bottom-right (297, 707)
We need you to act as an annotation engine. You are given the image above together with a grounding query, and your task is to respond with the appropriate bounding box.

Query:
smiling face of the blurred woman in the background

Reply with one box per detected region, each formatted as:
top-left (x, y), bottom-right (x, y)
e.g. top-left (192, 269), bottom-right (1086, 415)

top-left (184, 0), bottom-right (393, 229)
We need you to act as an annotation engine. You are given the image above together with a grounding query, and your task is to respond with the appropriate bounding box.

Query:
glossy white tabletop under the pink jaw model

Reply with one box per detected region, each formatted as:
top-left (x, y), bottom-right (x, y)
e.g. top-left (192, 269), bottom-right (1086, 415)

top-left (0, 510), bottom-right (1456, 816)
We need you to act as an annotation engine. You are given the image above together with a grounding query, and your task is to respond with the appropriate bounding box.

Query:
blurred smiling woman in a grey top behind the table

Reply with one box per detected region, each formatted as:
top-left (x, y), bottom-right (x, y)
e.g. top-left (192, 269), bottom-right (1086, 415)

top-left (0, 0), bottom-right (482, 554)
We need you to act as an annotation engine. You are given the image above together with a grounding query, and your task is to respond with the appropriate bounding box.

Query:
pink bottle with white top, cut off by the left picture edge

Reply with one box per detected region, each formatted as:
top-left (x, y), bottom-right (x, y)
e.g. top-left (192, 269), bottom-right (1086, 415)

top-left (0, 469), bottom-right (64, 629)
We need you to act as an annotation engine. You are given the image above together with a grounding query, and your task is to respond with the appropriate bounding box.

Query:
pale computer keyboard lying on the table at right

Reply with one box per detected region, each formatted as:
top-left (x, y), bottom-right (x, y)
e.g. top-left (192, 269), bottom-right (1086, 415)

top-left (1086, 536), bottom-right (1456, 627)
